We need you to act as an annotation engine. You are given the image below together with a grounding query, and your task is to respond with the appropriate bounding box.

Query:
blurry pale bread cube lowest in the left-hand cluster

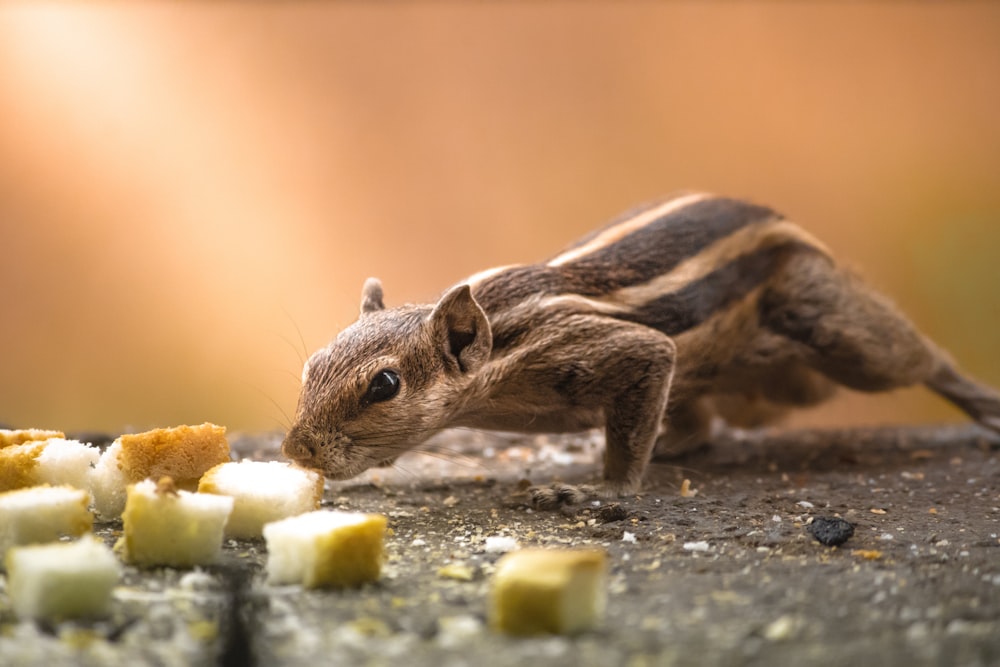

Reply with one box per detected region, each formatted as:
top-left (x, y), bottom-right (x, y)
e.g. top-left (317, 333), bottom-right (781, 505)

top-left (6, 535), bottom-right (121, 621)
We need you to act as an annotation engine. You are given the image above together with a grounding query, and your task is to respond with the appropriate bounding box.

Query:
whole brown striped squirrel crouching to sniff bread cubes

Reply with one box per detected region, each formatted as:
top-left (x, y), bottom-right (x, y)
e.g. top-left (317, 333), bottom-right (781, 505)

top-left (282, 194), bottom-right (1000, 494)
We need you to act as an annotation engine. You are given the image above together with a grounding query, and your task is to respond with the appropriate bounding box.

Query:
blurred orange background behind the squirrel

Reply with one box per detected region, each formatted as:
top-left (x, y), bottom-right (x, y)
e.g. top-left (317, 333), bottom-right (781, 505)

top-left (0, 2), bottom-right (1000, 432)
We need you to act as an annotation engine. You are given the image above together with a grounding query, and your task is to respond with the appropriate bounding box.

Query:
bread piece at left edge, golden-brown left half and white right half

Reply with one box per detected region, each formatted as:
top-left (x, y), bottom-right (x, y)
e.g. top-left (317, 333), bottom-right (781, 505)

top-left (0, 438), bottom-right (101, 491)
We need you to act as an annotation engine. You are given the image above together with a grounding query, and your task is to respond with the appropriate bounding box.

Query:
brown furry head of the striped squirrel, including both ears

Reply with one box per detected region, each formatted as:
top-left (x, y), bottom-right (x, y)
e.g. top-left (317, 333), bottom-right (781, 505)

top-left (281, 278), bottom-right (493, 479)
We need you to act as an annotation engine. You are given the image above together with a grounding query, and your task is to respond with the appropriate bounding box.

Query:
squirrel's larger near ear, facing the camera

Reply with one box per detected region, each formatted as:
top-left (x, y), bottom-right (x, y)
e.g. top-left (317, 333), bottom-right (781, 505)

top-left (430, 284), bottom-right (493, 373)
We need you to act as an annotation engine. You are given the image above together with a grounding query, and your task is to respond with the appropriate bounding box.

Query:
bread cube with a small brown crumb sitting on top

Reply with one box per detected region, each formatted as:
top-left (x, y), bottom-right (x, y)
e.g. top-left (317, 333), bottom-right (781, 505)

top-left (115, 477), bottom-right (233, 567)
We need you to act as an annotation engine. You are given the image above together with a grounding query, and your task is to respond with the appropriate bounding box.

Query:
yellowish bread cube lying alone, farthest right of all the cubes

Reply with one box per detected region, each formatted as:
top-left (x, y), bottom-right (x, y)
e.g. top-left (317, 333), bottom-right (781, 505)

top-left (490, 549), bottom-right (607, 635)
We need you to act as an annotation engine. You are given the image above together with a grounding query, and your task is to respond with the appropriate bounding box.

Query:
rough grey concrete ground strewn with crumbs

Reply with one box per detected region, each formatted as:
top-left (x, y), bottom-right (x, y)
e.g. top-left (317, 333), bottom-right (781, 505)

top-left (0, 426), bottom-right (1000, 667)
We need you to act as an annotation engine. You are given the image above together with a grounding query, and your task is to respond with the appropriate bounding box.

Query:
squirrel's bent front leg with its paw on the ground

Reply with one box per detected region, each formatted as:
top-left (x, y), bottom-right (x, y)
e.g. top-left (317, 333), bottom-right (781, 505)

top-left (532, 320), bottom-right (677, 508)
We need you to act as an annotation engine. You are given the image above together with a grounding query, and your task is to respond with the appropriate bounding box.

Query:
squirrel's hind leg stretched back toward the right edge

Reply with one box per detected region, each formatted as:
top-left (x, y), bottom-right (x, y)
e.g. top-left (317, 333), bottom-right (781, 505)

top-left (758, 253), bottom-right (1000, 430)
